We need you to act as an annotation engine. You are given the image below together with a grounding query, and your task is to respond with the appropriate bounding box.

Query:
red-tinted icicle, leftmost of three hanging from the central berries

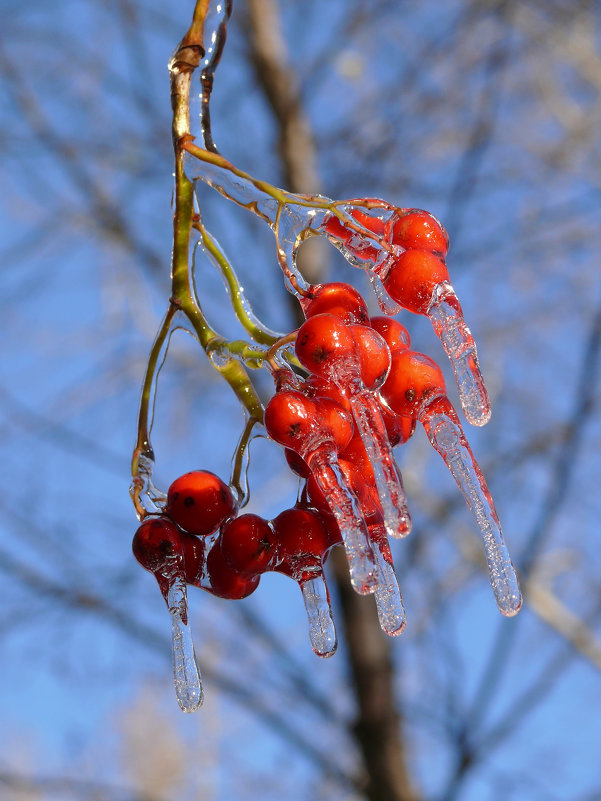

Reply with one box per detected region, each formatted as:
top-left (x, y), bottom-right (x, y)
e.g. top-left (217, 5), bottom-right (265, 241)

top-left (304, 449), bottom-right (377, 595)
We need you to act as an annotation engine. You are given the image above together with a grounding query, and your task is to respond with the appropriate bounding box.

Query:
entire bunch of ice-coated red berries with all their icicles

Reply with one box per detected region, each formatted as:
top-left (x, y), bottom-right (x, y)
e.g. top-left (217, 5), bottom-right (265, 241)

top-left (133, 200), bottom-right (521, 709)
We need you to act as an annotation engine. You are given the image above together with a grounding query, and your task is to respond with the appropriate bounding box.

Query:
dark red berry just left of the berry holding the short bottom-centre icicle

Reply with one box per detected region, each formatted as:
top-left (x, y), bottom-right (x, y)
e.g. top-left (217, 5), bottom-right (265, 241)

top-left (218, 514), bottom-right (276, 576)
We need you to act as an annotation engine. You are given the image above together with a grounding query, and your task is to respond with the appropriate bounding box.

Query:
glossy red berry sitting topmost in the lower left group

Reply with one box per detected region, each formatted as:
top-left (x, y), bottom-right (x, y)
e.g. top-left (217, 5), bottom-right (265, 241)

top-left (165, 470), bottom-right (236, 537)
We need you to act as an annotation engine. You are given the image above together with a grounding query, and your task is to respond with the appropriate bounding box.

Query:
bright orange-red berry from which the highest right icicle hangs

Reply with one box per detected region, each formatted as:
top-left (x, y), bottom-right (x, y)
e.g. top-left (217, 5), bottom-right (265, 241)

top-left (383, 250), bottom-right (449, 314)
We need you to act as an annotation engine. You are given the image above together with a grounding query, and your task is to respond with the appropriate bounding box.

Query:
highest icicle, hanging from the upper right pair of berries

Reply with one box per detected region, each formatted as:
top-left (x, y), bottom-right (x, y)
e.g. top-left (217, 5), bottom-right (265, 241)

top-left (428, 281), bottom-right (491, 426)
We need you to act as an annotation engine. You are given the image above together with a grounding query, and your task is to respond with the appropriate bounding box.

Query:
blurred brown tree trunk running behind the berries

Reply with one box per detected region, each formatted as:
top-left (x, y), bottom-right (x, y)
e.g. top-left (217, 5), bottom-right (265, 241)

top-left (247, 0), bottom-right (418, 801)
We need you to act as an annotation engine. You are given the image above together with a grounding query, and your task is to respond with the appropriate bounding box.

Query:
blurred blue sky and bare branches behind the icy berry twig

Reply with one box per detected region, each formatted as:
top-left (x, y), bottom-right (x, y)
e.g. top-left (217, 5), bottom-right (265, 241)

top-left (0, 0), bottom-right (601, 801)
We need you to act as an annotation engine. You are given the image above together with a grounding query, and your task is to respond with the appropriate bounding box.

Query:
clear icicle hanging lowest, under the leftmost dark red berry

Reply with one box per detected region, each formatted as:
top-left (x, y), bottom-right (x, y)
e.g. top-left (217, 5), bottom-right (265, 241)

top-left (167, 575), bottom-right (204, 712)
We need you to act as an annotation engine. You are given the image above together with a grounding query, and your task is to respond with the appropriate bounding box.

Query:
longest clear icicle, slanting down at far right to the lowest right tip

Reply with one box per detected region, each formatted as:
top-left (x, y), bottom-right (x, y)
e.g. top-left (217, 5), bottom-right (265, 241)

top-left (420, 400), bottom-right (522, 617)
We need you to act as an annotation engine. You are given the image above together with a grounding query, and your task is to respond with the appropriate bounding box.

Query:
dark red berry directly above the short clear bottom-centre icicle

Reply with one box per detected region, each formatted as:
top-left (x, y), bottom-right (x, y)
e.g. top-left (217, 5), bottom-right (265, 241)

top-left (272, 506), bottom-right (330, 581)
